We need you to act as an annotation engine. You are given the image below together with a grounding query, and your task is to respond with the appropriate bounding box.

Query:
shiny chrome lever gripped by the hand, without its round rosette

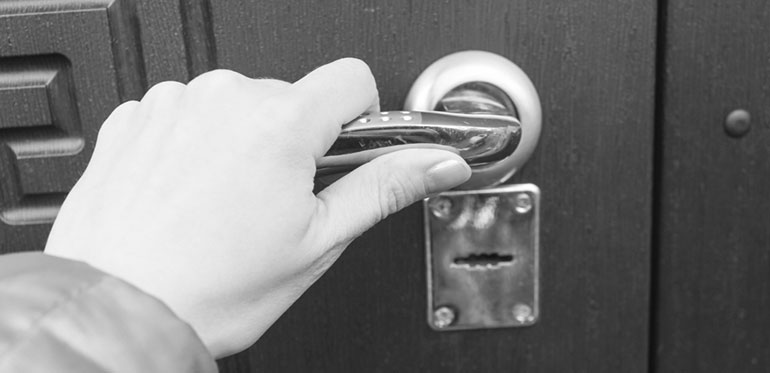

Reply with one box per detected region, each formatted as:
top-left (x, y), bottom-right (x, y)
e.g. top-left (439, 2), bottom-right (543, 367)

top-left (316, 111), bottom-right (521, 175)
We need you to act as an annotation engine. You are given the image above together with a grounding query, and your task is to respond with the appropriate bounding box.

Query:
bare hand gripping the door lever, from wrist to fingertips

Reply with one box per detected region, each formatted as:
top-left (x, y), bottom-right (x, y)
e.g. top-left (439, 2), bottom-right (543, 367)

top-left (46, 59), bottom-right (470, 357)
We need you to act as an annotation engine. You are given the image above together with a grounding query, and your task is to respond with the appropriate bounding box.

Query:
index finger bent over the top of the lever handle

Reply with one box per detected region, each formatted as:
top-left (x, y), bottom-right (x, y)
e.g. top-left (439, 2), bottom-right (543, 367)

top-left (290, 58), bottom-right (379, 158)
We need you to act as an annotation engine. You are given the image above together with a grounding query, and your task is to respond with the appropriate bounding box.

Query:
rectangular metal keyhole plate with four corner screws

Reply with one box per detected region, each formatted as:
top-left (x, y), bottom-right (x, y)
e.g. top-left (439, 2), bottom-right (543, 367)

top-left (423, 184), bottom-right (540, 331)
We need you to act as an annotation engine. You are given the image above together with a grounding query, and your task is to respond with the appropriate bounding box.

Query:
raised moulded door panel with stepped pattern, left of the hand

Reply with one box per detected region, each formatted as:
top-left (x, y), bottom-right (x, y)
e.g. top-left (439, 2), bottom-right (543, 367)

top-left (0, 1), bottom-right (145, 253)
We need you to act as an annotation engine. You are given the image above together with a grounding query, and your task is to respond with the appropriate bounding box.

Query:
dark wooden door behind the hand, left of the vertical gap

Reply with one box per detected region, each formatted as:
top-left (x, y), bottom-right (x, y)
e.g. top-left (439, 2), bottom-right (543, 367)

top-left (0, 0), bottom-right (657, 372)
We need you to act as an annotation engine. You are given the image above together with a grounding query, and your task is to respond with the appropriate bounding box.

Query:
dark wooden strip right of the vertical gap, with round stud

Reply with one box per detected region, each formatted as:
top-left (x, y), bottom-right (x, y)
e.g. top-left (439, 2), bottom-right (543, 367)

top-left (654, 0), bottom-right (770, 372)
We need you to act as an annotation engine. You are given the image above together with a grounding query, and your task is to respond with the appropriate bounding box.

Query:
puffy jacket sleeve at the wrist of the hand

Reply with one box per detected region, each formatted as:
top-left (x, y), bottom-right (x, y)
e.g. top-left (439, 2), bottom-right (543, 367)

top-left (0, 253), bottom-right (217, 372)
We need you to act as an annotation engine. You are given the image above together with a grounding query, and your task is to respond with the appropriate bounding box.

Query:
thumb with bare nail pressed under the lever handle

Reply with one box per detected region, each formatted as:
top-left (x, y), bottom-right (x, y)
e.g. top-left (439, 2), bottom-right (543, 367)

top-left (318, 149), bottom-right (471, 243)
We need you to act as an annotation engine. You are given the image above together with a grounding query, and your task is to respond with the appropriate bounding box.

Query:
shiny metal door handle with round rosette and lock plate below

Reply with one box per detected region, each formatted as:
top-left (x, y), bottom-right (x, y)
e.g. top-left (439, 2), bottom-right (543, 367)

top-left (332, 51), bottom-right (541, 331)
